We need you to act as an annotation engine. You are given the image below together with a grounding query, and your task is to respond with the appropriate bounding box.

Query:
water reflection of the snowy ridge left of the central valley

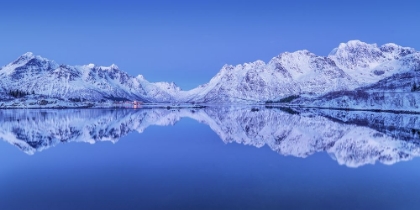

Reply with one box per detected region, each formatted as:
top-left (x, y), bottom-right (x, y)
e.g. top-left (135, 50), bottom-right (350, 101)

top-left (0, 109), bottom-right (179, 154)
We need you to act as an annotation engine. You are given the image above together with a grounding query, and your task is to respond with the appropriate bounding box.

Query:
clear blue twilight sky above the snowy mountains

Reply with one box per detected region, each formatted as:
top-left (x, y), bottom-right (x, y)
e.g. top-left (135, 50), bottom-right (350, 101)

top-left (0, 0), bottom-right (420, 89)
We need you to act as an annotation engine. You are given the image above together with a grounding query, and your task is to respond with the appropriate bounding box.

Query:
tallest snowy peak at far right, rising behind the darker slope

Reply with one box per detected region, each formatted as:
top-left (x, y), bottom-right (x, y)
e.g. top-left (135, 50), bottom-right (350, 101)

top-left (328, 40), bottom-right (420, 86)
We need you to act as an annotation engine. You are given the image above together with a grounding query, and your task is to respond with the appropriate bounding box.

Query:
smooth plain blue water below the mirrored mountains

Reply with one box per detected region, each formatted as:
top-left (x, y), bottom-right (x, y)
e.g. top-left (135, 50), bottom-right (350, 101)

top-left (0, 110), bottom-right (420, 210)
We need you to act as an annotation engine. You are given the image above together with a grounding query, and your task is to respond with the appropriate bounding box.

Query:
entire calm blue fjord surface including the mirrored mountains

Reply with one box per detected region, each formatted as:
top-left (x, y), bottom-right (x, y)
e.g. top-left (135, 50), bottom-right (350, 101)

top-left (0, 106), bottom-right (420, 210)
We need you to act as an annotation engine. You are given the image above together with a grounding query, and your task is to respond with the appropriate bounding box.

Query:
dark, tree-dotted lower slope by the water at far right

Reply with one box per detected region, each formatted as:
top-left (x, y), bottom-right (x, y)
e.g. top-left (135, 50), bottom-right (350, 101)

top-left (292, 68), bottom-right (420, 112)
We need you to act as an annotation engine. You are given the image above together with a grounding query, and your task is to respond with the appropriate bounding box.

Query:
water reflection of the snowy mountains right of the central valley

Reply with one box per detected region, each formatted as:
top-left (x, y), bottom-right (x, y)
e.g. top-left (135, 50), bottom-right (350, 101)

top-left (198, 108), bottom-right (420, 167)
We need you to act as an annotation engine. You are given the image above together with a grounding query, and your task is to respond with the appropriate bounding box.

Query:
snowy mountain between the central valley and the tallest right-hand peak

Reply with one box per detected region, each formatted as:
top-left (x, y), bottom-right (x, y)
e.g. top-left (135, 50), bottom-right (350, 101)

top-left (180, 51), bottom-right (358, 102)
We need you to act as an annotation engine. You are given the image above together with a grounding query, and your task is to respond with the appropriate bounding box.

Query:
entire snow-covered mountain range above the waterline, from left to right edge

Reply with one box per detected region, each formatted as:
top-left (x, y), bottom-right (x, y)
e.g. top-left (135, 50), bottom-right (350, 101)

top-left (0, 40), bottom-right (420, 109)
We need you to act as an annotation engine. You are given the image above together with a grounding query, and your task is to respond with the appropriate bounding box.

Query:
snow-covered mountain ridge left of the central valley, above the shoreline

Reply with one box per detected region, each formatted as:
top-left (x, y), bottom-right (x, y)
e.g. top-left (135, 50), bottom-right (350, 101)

top-left (0, 53), bottom-right (179, 102)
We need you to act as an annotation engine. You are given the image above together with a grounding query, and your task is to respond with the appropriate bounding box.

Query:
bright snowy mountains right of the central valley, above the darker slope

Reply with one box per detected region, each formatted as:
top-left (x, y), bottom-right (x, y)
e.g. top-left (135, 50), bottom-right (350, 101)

top-left (184, 40), bottom-right (420, 103)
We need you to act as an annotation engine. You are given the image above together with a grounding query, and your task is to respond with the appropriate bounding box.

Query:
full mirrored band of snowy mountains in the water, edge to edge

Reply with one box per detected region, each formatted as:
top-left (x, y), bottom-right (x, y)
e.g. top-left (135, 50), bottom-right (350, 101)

top-left (0, 106), bottom-right (420, 167)
